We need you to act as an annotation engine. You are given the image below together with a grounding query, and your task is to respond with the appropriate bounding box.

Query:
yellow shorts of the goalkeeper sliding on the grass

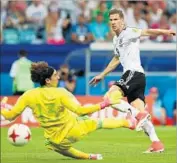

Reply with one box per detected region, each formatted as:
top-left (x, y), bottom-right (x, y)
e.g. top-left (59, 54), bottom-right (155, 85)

top-left (45, 119), bottom-right (97, 151)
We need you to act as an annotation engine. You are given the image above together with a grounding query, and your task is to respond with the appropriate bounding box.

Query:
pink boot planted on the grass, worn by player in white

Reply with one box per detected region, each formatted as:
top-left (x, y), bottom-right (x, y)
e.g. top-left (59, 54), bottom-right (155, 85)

top-left (143, 141), bottom-right (164, 153)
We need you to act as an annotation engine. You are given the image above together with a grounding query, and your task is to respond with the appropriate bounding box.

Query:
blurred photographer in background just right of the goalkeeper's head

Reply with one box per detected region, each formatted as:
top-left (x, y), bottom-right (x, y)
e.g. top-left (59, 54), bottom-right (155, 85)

top-left (59, 64), bottom-right (76, 93)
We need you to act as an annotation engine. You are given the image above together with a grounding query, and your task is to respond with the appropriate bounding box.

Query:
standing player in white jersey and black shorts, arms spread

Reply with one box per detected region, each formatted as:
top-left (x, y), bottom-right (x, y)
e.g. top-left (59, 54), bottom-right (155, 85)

top-left (90, 9), bottom-right (176, 153)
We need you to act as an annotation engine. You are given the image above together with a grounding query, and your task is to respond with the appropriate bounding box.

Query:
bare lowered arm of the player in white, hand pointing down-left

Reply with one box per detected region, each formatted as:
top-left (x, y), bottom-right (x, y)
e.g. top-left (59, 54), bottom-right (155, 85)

top-left (89, 56), bottom-right (120, 85)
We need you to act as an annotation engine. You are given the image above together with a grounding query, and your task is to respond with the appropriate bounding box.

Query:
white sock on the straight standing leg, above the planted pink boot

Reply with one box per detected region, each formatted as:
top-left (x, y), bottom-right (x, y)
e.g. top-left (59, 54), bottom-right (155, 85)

top-left (142, 120), bottom-right (160, 142)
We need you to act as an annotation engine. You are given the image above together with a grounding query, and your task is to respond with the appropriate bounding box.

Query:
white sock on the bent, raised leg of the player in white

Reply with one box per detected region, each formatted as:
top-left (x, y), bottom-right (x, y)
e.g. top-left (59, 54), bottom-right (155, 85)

top-left (112, 100), bottom-right (140, 117)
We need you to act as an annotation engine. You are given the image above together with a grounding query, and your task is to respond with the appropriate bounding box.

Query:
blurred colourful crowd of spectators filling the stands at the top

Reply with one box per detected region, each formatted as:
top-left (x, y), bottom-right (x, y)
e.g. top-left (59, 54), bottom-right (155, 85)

top-left (0, 0), bottom-right (176, 44)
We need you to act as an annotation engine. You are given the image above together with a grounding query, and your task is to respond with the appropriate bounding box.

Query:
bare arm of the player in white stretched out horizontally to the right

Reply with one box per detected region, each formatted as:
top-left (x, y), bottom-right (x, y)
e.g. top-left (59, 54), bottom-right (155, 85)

top-left (141, 29), bottom-right (176, 36)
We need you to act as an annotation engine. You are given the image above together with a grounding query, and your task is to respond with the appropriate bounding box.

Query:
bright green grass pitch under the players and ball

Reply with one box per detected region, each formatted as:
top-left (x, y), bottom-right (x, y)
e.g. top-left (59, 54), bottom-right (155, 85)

top-left (1, 127), bottom-right (176, 163)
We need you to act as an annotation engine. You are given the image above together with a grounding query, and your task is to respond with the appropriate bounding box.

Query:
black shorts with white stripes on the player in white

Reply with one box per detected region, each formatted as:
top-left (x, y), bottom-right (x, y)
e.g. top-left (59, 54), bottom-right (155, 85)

top-left (115, 70), bottom-right (146, 103)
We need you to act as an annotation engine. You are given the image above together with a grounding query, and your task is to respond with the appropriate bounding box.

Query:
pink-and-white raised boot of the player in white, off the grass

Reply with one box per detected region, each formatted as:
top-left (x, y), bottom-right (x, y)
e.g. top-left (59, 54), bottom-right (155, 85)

top-left (136, 111), bottom-right (151, 131)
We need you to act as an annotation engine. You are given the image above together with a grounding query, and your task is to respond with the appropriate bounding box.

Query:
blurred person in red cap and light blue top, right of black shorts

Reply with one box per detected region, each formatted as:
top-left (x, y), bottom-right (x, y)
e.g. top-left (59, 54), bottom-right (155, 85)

top-left (149, 87), bottom-right (166, 125)
